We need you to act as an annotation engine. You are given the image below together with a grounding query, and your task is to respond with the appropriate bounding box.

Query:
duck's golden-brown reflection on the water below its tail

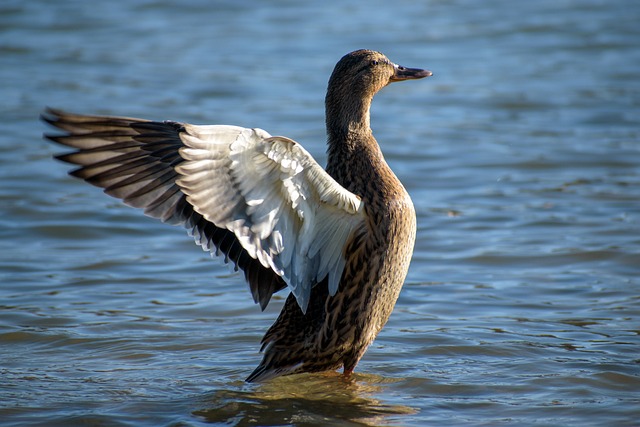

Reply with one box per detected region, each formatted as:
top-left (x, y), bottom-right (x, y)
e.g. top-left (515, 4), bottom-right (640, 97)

top-left (193, 372), bottom-right (417, 427)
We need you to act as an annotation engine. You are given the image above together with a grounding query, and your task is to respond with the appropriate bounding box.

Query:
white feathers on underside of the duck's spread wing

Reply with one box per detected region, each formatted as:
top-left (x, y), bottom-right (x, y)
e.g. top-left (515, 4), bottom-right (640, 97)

top-left (175, 125), bottom-right (364, 312)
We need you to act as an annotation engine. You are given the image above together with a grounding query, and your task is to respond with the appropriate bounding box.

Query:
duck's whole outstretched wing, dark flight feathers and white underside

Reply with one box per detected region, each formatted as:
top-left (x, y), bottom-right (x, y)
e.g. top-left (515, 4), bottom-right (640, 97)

top-left (43, 109), bottom-right (364, 311)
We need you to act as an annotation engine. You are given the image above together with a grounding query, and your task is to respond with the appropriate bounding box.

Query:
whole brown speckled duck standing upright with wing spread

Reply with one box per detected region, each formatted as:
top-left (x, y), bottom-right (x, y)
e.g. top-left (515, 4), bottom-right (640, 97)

top-left (42, 50), bottom-right (431, 381)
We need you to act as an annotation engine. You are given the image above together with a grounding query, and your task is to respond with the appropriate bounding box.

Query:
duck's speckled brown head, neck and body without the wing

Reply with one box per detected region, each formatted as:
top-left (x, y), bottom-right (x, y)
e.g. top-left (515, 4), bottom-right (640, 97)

top-left (248, 50), bottom-right (431, 381)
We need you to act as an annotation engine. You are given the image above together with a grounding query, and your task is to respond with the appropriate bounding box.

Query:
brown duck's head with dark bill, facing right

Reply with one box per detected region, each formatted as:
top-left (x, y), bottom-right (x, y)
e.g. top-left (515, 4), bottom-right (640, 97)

top-left (329, 49), bottom-right (432, 97)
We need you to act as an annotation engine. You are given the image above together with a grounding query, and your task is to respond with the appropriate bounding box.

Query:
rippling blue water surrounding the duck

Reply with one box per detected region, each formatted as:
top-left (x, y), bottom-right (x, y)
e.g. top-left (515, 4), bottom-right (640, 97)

top-left (0, 0), bottom-right (640, 426)
